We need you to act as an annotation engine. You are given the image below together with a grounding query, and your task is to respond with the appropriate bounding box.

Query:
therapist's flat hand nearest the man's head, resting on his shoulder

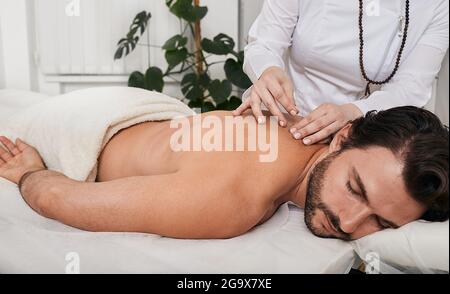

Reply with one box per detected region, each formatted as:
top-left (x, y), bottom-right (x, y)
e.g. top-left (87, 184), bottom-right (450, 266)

top-left (290, 103), bottom-right (363, 145)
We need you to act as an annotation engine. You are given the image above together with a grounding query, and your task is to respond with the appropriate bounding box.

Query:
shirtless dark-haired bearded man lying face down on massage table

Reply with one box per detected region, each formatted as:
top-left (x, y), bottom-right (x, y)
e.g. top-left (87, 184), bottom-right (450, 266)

top-left (0, 107), bottom-right (449, 240)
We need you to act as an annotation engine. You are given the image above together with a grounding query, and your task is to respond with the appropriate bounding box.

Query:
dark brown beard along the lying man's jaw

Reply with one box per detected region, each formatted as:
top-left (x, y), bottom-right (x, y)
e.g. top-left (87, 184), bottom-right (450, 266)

top-left (305, 151), bottom-right (352, 241)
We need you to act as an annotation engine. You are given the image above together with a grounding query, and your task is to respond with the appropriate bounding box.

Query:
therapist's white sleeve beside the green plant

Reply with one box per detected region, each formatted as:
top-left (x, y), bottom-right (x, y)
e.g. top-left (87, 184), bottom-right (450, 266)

top-left (244, 0), bottom-right (300, 82)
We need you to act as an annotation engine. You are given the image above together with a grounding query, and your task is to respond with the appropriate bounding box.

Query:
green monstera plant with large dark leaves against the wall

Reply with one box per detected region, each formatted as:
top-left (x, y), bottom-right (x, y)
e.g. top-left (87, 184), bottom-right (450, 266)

top-left (114, 0), bottom-right (252, 112)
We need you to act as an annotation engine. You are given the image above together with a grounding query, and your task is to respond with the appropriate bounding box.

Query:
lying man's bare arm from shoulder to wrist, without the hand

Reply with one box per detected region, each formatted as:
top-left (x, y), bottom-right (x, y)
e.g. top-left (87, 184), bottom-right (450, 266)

top-left (22, 171), bottom-right (257, 239)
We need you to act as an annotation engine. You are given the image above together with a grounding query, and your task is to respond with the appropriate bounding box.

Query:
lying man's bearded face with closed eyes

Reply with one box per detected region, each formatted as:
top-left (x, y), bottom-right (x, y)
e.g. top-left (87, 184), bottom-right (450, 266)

top-left (305, 147), bottom-right (426, 240)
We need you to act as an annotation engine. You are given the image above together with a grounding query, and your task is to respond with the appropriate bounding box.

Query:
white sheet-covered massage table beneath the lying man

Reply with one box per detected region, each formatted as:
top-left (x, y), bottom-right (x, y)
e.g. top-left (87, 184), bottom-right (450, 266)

top-left (0, 90), bottom-right (357, 274)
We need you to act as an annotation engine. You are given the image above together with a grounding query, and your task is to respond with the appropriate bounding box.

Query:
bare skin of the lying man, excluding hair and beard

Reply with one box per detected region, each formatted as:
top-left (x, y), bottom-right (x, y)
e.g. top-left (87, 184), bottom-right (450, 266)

top-left (0, 112), bottom-right (425, 239)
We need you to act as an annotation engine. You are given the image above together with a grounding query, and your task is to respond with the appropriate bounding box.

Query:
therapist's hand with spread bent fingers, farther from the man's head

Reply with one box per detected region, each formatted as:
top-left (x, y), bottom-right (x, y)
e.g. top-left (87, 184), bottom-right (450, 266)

top-left (233, 66), bottom-right (298, 127)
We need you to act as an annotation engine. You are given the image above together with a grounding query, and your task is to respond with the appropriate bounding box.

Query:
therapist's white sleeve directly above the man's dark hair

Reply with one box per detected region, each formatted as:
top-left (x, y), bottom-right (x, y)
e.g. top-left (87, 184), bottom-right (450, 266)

top-left (353, 0), bottom-right (449, 114)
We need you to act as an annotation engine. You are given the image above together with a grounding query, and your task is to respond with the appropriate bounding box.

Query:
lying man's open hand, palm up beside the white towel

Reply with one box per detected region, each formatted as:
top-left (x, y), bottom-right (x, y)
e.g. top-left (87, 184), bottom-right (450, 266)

top-left (0, 136), bottom-right (46, 184)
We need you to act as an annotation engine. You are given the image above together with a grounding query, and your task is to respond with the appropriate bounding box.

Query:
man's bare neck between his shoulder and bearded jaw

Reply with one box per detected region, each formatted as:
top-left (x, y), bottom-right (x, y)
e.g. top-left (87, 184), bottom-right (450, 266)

top-left (285, 145), bottom-right (329, 208)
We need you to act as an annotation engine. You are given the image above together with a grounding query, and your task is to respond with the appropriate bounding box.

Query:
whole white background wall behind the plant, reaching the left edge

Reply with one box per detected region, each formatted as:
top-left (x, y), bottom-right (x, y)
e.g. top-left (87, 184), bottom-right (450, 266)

top-left (0, 0), bottom-right (246, 95)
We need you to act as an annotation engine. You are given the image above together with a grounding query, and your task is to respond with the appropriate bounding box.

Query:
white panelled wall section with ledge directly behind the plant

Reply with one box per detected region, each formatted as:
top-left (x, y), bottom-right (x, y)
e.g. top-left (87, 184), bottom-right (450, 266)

top-left (29, 0), bottom-right (239, 97)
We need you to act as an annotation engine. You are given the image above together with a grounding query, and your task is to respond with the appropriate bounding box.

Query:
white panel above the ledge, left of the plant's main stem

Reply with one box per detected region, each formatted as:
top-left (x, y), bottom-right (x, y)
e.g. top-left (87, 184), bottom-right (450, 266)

top-left (35, 0), bottom-right (179, 75)
